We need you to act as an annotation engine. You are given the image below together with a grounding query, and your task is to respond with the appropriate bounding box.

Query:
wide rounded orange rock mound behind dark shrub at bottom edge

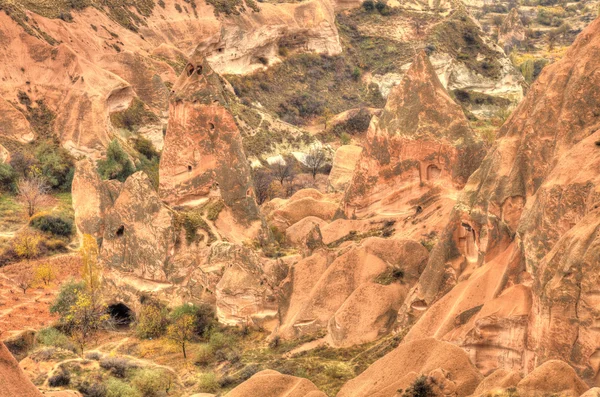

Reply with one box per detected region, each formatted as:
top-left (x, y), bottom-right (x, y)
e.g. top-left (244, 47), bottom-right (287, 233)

top-left (337, 339), bottom-right (482, 397)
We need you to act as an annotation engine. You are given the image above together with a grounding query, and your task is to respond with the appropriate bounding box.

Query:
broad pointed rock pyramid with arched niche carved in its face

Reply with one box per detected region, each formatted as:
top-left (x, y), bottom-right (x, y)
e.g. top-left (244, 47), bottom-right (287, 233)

top-left (345, 52), bottom-right (484, 238)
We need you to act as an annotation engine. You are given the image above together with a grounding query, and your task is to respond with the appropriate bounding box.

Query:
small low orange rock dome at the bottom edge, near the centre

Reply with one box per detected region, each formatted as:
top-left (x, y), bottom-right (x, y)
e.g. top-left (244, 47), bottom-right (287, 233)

top-left (227, 370), bottom-right (326, 397)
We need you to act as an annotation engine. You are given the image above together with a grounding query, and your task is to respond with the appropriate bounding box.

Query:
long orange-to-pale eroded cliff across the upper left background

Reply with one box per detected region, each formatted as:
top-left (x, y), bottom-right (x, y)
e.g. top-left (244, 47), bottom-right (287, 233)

top-left (0, 0), bottom-right (341, 158)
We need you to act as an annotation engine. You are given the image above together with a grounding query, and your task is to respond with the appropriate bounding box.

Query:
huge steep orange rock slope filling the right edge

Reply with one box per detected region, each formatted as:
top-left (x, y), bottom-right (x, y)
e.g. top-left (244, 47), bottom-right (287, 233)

top-left (399, 17), bottom-right (600, 380)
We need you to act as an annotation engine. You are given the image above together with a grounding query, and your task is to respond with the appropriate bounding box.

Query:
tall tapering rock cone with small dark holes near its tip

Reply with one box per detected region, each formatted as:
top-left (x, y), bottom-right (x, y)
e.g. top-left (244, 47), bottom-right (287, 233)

top-left (159, 53), bottom-right (258, 224)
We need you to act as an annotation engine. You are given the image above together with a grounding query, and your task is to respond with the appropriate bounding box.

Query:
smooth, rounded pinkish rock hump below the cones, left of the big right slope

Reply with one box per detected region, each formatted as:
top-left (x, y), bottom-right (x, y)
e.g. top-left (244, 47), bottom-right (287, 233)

top-left (279, 238), bottom-right (427, 346)
